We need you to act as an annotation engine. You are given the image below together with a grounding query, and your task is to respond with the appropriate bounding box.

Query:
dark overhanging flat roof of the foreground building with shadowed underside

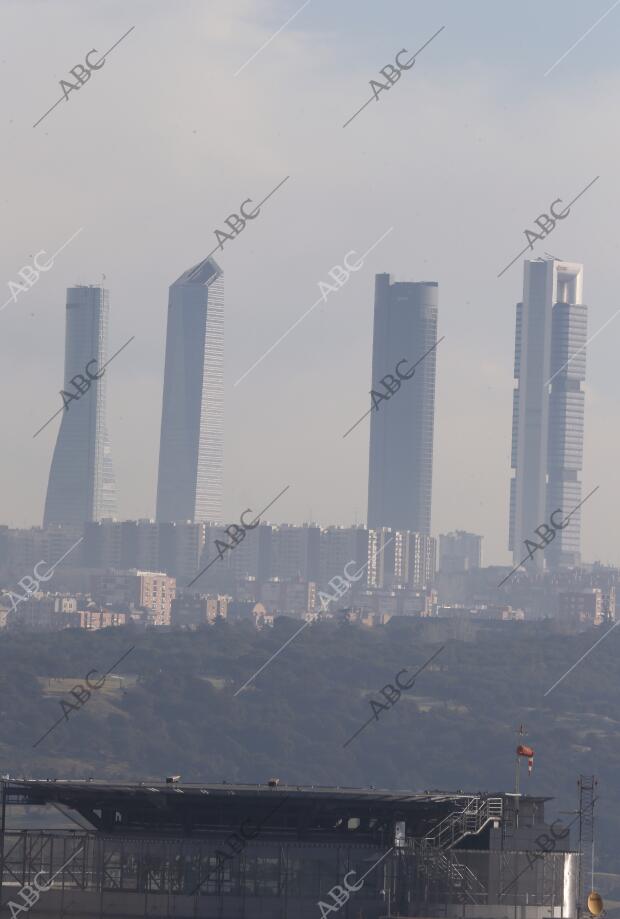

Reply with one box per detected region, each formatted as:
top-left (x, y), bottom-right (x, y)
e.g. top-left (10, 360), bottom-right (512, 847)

top-left (1, 778), bottom-right (548, 844)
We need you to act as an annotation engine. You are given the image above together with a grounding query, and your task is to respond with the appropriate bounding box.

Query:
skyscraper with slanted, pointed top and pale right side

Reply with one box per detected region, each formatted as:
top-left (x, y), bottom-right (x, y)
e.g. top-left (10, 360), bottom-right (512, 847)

top-left (157, 258), bottom-right (224, 523)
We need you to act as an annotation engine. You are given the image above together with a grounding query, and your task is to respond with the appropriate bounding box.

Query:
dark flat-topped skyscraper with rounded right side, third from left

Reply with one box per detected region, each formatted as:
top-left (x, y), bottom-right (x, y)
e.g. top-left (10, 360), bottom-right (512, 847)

top-left (368, 274), bottom-right (438, 535)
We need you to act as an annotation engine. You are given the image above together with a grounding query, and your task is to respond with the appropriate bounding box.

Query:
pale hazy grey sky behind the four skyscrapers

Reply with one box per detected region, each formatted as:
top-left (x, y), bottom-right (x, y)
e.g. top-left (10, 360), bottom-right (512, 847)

top-left (0, 0), bottom-right (620, 564)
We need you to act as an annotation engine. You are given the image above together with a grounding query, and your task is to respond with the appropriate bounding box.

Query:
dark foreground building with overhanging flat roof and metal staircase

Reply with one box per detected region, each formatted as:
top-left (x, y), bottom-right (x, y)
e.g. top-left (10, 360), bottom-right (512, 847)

top-left (0, 777), bottom-right (578, 919)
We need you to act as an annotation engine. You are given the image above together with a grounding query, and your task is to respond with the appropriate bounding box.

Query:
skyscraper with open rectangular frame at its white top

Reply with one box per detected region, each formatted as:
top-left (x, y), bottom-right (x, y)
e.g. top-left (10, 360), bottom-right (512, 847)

top-left (509, 258), bottom-right (588, 570)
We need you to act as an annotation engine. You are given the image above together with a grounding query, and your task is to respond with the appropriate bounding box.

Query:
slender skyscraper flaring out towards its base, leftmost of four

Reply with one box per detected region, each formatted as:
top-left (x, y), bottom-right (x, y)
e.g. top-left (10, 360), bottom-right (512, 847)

top-left (43, 285), bottom-right (116, 526)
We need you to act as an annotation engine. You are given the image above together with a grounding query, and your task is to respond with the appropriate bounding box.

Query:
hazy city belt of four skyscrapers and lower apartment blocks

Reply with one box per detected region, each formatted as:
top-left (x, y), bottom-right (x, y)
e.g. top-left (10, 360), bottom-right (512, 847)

top-left (0, 257), bottom-right (620, 629)
